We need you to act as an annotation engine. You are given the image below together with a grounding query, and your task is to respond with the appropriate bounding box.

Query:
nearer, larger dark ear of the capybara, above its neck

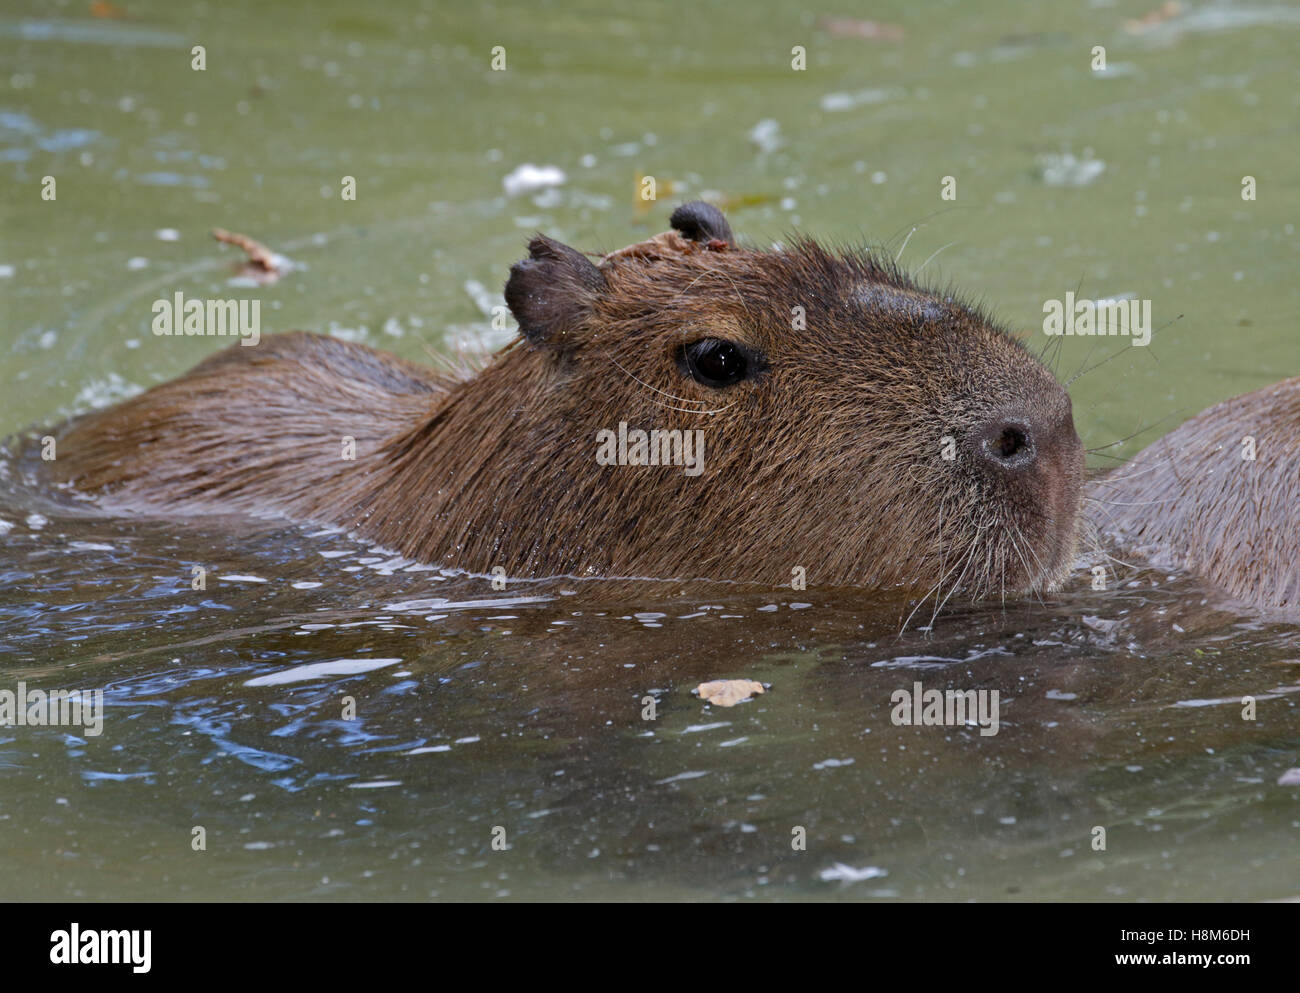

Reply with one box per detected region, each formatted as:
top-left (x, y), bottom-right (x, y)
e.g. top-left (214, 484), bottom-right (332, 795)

top-left (506, 234), bottom-right (606, 347)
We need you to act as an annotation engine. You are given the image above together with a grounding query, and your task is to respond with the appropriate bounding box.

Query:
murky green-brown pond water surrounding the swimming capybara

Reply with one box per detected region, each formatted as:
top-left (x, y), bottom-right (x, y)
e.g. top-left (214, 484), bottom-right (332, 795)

top-left (0, 0), bottom-right (1300, 901)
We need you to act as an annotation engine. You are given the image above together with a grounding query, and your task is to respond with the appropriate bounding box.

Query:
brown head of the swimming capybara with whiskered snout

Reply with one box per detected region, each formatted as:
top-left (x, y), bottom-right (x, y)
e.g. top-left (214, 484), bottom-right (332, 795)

top-left (506, 203), bottom-right (1083, 602)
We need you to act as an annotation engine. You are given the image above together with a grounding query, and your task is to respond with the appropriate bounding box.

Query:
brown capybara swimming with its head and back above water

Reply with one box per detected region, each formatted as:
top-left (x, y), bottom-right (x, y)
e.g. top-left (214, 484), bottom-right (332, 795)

top-left (49, 204), bottom-right (1083, 602)
